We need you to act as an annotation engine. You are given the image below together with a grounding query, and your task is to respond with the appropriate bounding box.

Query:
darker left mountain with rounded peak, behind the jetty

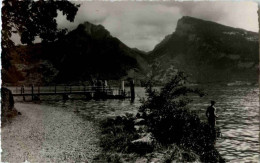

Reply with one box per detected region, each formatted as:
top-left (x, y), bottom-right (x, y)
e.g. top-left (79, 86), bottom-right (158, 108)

top-left (3, 22), bottom-right (147, 84)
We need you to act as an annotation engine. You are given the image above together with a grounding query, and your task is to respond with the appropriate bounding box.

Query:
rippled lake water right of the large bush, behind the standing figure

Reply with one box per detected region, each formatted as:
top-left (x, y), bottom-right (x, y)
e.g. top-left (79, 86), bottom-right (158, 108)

top-left (188, 86), bottom-right (259, 162)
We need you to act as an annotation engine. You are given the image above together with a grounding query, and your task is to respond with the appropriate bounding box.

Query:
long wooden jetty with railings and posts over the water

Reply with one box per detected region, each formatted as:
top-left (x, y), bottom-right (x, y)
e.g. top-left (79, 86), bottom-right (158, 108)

top-left (8, 81), bottom-right (135, 100)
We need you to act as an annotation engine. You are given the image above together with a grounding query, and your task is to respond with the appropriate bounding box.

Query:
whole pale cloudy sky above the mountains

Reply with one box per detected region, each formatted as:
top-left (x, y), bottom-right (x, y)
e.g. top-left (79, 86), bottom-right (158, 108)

top-left (12, 1), bottom-right (258, 51)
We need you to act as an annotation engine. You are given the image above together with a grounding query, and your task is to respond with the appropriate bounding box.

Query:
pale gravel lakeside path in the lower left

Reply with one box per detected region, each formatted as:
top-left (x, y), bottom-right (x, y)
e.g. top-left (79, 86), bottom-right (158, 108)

top-left (1, 103), bottom-right (100, 163)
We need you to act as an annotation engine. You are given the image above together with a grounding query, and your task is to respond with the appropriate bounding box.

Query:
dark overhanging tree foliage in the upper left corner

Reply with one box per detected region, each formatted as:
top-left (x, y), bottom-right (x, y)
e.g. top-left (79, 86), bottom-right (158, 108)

top-left (2, 0), bottom-right (79, 67)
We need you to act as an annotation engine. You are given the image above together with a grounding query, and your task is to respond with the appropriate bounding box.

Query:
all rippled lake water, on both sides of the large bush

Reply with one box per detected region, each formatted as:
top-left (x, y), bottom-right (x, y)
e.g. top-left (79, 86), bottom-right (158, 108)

top-left (11, 86), bottom-right (259, 162)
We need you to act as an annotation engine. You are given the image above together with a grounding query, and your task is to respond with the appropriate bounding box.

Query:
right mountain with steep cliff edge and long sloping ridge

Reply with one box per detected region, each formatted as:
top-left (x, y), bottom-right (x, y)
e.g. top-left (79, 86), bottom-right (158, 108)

top-left (149, 16), bottom-right (259, 83)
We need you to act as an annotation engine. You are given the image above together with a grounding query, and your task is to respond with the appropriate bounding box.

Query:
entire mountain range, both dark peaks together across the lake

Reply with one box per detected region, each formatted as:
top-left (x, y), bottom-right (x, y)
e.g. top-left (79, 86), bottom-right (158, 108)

top-left (2, 16), bottom-right (259, 84)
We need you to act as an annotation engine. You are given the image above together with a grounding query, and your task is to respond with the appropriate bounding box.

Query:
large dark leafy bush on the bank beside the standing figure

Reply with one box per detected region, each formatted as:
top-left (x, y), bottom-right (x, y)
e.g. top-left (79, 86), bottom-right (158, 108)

top-left (140, 72), bottom-right (222, 162)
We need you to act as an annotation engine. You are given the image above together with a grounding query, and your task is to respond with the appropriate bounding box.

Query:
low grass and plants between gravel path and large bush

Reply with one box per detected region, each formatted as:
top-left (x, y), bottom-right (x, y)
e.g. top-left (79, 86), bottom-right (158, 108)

top-left (94, 114), bottom-right (202, 163)
